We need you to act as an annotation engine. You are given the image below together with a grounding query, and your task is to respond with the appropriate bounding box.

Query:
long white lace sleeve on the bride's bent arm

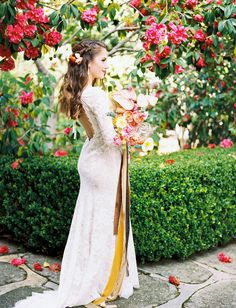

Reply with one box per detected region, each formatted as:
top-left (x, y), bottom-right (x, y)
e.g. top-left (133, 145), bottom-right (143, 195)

top-left (81, 87), bottom-right (121, 149)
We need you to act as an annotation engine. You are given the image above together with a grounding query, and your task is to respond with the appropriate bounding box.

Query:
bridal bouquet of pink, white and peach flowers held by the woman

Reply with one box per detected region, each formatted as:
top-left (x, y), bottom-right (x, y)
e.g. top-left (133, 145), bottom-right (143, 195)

top-left (109, 88), bottom-right (157, 146)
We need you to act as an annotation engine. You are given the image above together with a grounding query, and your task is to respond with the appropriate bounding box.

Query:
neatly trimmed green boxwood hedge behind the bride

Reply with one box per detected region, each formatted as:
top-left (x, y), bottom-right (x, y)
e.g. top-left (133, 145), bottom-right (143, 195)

top-left (0, 147), bottom-right (236, 262)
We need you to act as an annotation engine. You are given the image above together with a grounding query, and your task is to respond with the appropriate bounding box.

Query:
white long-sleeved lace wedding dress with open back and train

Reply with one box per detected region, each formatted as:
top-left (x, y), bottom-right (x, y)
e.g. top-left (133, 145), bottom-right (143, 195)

top-left (14, 86), bottom-right (139, 308)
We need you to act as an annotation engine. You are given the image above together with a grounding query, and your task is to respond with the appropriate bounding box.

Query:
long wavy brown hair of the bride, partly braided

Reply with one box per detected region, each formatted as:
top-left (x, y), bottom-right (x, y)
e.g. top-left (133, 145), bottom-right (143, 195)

top-left (58, 39), bottom-right (107, 119)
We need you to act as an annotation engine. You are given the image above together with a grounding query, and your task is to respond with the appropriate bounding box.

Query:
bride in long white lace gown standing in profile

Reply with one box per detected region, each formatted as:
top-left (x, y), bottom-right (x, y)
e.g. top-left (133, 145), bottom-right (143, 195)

top-left (12, 40), bottom-right (139, 308)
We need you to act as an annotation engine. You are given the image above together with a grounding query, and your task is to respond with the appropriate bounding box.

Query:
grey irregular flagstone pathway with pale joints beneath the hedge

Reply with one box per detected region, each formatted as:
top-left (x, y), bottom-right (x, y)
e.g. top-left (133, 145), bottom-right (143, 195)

top-left (0, 239), bottom-right (236, 308)
